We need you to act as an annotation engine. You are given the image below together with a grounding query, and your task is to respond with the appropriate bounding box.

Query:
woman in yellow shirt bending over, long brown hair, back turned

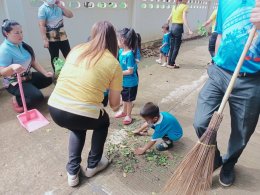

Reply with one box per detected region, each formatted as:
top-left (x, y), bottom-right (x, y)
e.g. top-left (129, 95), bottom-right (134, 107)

top-left (48, 22), bottom-right (123, 186)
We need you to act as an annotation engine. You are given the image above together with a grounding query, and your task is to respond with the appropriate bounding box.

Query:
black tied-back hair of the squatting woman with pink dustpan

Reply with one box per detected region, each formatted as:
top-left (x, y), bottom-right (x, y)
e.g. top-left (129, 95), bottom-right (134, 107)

top-left (2, 19), bottom-right (35, 61)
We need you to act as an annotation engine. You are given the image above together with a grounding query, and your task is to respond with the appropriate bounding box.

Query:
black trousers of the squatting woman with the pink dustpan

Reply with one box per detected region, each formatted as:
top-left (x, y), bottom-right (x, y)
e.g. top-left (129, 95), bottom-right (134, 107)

top-left (6, 72), bottom-right (52, 108)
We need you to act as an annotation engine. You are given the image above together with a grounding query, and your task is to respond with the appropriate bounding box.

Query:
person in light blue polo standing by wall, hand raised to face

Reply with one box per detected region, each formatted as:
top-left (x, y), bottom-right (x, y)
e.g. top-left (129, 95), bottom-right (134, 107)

top-left (38, 0), bottom-right (73, 70)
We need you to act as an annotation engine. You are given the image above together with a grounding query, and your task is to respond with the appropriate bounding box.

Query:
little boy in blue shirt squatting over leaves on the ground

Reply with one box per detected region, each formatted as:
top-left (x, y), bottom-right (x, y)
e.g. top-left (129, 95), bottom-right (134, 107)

top-left (133, 102), bottom-right (183, 155)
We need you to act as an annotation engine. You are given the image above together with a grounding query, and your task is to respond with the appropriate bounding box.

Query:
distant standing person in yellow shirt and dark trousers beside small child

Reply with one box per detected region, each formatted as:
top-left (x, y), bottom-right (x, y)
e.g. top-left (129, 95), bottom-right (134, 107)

top-left (167, 0), bottom-right (192, 68)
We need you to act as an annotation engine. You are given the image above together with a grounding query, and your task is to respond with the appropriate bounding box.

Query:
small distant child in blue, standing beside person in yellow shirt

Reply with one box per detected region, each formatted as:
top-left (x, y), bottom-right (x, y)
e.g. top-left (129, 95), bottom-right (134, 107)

top-left (156, 24), bottom-right (170, 67)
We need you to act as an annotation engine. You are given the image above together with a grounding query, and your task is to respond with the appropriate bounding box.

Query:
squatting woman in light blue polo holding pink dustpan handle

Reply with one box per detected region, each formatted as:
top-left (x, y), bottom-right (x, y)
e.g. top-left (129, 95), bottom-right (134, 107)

top-left (0, 20), bottom-right (53, 113)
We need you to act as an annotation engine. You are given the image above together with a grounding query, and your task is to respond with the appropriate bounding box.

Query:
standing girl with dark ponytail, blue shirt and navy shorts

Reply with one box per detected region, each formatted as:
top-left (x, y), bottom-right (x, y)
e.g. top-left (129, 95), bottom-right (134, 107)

top-left (115, 28), bottom-right (138, 125)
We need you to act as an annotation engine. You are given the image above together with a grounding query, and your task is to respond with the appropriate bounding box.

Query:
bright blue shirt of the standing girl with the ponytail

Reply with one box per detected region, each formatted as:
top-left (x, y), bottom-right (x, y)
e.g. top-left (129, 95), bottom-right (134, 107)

top-left (119, 49), bottom-right (138, 87)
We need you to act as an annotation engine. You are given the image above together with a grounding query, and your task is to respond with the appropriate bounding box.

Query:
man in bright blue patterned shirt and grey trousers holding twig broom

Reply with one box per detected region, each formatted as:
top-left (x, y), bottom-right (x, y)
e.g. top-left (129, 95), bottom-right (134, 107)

top-left (194, 0), bottom-right (260, 186)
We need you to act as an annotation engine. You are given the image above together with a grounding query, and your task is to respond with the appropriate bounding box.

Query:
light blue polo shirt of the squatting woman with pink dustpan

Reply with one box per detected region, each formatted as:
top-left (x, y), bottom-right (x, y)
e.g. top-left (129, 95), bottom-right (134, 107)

top-left (0, 39), bottom-right (32, 87)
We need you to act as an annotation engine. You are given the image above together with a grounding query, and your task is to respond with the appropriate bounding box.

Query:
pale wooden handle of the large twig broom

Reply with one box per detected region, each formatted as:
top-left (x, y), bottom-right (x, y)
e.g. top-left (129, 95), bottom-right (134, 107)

top-left (218, 26), bottom-right (256, 114)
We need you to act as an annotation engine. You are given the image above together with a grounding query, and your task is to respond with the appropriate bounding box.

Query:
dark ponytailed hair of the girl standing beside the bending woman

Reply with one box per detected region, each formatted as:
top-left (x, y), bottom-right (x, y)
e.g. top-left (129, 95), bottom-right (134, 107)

top-left (118, 28), bottom-right (138, 55)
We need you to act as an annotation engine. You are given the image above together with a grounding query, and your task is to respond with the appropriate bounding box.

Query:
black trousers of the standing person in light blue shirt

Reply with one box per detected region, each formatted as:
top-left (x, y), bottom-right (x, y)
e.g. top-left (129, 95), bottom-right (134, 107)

top-left (49, 40), bottom-right (70, 70)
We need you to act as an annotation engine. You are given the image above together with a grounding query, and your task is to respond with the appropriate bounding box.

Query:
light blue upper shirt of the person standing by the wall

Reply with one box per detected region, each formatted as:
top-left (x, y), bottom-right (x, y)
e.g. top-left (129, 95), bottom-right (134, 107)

top-left (38, 3), bottom-right (64, 32)
